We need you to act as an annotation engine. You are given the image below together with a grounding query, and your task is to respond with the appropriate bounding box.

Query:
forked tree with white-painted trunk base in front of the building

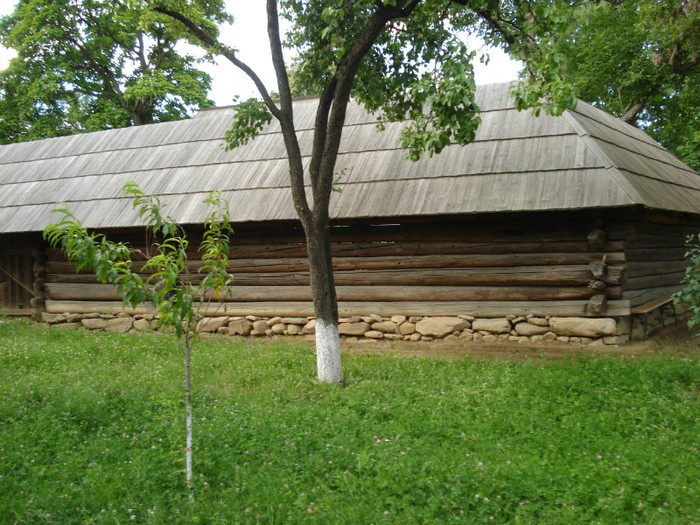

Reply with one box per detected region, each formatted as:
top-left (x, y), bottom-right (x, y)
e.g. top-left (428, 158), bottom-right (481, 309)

top-left (150, 0), bottom-right (573, 382)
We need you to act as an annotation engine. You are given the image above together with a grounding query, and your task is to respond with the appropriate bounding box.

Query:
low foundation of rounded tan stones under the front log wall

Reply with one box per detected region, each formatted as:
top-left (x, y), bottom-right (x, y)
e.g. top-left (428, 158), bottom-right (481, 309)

top-left (42, 313), bottom-right (631, 345)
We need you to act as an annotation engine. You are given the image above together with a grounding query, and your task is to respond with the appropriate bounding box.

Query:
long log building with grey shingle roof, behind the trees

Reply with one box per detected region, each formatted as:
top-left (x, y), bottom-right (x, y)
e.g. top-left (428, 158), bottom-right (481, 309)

top-left (0, 84), bottom-right (700, 340)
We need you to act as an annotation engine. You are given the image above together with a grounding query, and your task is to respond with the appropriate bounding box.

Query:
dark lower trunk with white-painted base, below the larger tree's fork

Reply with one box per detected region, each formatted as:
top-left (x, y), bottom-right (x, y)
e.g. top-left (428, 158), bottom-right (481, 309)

top-left (305, 219), bottom-right (343, 383)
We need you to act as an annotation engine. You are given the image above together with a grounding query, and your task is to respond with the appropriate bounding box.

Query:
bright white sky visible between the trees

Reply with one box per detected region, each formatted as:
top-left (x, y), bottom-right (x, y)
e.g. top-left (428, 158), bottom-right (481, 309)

top-left (0, 0), bottom-right (520, 106)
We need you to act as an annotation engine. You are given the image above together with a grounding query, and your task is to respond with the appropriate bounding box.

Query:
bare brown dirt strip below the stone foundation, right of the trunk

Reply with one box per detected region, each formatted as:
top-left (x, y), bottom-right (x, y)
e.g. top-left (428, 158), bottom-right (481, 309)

top-left (342, 323), bottom-right (700, 360)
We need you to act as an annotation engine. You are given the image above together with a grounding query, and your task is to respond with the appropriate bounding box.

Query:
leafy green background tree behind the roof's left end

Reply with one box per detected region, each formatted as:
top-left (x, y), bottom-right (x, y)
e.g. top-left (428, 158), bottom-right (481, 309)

top-left (0, 0), bottom-right (230, 143)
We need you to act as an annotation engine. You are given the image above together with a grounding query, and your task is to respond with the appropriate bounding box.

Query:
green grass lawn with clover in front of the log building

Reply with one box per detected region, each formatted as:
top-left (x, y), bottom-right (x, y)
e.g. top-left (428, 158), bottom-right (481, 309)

top-left (0, 320), bottom-right (700, 524)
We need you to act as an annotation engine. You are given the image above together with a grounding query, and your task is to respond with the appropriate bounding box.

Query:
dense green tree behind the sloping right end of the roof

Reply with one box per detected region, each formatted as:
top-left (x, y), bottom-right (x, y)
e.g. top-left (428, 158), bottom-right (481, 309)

top-left (555, 0), bottom-right (700, 170)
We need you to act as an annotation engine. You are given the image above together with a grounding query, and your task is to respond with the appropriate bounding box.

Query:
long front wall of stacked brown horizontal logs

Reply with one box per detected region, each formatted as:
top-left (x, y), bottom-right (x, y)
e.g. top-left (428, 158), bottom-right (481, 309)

top-left (46, 210), bottom-right (627, 317)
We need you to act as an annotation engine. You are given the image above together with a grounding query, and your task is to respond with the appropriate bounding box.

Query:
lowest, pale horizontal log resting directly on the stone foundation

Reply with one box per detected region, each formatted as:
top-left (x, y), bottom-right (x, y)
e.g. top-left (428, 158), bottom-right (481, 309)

top-left (46, 300), bottom-right (630, 317)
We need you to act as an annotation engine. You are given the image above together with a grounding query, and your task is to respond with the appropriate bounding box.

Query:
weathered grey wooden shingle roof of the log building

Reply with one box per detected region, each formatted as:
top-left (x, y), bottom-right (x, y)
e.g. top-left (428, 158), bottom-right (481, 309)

top-left (0, 84), bottom-right (700, 232)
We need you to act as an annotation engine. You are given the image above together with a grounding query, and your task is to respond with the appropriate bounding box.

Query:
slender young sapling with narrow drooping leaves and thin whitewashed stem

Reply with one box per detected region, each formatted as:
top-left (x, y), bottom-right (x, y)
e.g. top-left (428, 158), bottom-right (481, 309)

top-left (44, 182), bottom-right (233, 494)
